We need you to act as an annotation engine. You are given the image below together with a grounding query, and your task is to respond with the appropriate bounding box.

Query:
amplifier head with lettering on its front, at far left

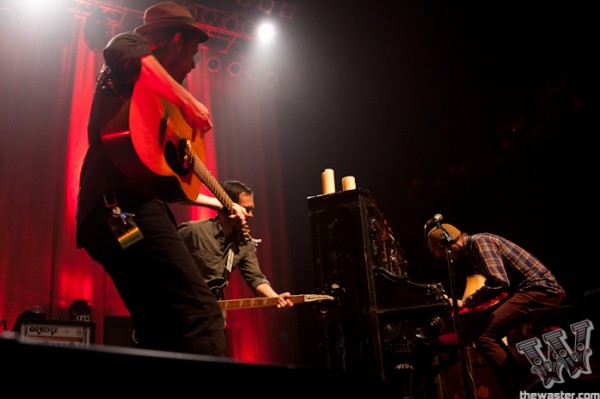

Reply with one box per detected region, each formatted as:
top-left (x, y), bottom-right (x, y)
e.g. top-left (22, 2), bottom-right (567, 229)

top-left (19, 319), bottom-right (96, 346)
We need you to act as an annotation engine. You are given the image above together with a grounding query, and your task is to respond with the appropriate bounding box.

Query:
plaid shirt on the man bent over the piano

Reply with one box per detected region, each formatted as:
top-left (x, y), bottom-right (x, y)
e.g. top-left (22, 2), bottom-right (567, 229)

top-left (464, 233), bottom-right (565, 307)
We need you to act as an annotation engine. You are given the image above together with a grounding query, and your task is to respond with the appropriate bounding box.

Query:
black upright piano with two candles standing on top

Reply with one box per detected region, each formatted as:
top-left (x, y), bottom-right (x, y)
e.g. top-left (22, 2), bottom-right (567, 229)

top-left (308, 189), bottom-right (448, 397)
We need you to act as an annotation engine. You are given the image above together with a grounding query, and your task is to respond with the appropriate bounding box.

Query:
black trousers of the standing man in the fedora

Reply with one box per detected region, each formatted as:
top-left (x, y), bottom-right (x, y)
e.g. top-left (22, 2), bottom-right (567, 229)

top-left (79, 193), bottom-right (227, 356)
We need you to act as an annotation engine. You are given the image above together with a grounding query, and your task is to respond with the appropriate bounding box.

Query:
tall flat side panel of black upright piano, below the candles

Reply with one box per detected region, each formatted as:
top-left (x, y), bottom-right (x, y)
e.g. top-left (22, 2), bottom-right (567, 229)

top-left (308, 189), bottom-right (396, 382)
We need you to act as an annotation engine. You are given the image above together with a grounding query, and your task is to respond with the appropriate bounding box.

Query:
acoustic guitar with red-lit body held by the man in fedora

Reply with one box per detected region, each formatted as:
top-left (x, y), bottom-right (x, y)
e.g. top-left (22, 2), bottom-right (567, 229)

top-left (101, 85), bottom-right (256, 245)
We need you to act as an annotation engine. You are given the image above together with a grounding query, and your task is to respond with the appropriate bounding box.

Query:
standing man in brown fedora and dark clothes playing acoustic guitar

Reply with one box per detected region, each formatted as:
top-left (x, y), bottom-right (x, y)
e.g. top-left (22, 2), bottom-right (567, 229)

top-left (77, 2), bottom-right (247, 356)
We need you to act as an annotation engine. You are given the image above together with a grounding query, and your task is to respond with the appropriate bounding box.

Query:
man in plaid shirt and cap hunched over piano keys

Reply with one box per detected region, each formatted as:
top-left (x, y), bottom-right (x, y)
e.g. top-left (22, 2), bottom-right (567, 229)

top-left (427, 223), bottom-right (565, 397)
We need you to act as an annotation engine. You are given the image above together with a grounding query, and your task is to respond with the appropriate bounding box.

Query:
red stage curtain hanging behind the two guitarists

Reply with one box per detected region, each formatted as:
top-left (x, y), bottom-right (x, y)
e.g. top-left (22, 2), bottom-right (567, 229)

top-left (0, 9), bottom-right (298, 363)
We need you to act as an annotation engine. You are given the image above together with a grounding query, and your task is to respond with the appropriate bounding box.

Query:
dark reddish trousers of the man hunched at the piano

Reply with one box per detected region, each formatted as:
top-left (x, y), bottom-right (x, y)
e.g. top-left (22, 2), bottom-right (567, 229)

top-left (473, 290), bottom-right (562, 397)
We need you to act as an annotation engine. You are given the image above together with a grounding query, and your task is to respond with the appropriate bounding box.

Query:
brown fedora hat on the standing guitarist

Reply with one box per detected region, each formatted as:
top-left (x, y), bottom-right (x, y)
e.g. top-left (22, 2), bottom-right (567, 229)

top-left (133, 1), bottom-right (208, 42)
